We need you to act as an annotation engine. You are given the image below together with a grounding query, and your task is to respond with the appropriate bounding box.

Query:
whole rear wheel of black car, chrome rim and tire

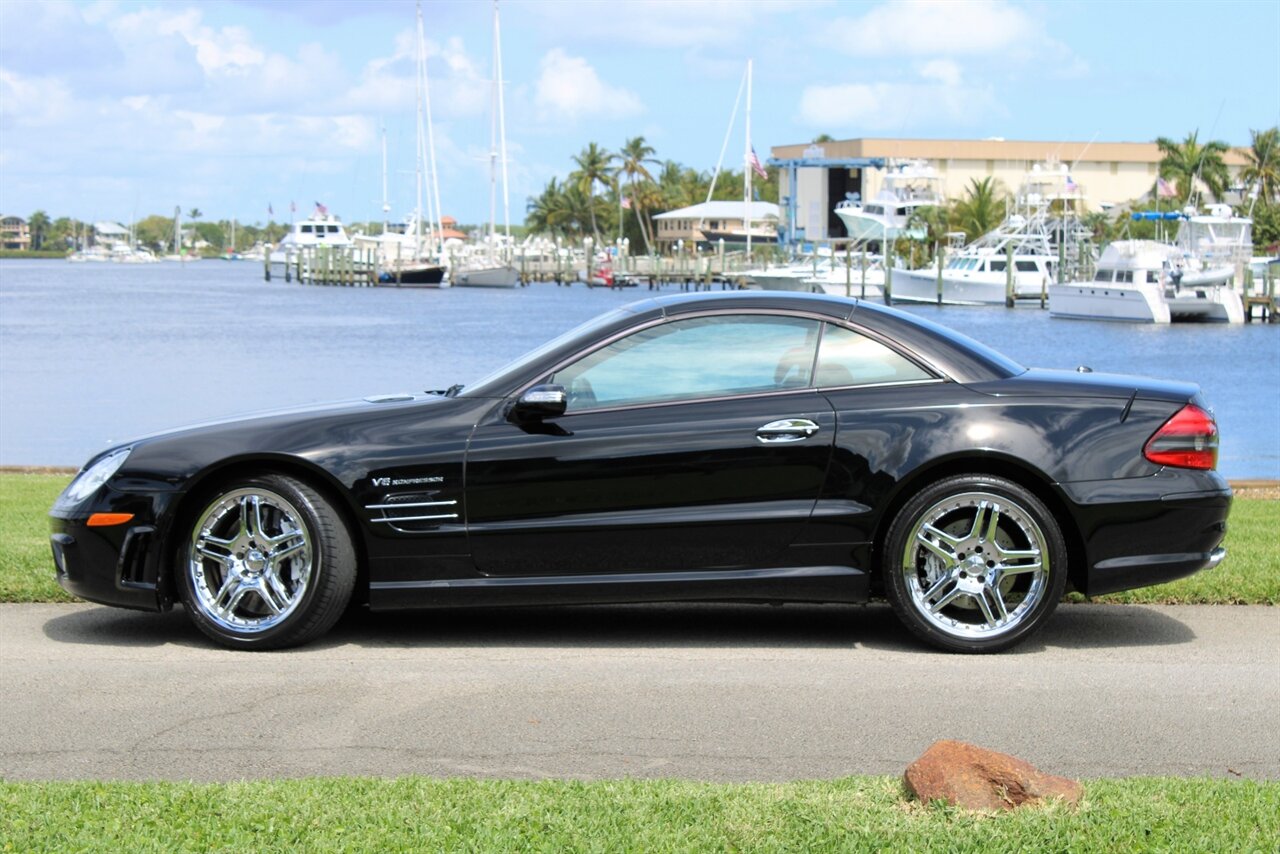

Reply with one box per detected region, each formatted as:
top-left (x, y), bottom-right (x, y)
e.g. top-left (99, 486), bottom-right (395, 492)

top-left (883, 475), bottom-right (1066, 653)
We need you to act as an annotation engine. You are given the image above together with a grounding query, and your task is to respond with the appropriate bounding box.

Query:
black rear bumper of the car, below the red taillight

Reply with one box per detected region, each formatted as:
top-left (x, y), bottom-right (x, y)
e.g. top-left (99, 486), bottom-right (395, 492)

top-left (1064, 469), bottom-right (1231, 595)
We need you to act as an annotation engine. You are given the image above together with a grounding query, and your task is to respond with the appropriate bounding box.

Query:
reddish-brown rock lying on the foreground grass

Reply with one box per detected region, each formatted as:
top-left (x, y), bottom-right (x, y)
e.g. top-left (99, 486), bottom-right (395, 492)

top-left (904, 741), bottom-right (1084, 810)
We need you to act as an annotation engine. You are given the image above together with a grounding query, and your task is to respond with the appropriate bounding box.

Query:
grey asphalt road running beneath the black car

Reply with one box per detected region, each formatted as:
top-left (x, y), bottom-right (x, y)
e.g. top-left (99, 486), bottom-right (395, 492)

top-left (0, 604), bottom-right (1280, 781)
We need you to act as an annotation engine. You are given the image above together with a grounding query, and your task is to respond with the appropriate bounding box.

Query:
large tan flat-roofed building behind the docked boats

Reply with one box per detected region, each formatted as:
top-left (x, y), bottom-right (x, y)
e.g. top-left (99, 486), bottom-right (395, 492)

top-left (771, 138), bottom-right (1245, 239)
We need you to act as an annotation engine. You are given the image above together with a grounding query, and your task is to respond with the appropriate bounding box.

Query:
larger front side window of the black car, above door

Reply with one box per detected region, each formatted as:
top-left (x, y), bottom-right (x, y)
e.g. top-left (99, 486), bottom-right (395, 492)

top-left (550, 315), bottom-right (819, 412)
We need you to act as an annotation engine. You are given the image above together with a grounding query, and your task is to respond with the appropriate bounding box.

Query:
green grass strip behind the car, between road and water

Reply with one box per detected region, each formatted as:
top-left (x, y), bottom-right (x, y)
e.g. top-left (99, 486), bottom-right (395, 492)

top-left (0, 474), bottom-right (1280, 604)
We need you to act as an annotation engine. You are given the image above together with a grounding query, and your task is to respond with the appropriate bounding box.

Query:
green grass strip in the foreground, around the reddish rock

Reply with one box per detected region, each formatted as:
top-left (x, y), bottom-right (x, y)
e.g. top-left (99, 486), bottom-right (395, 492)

top-left (0, 777), bottom-right (1280, 854)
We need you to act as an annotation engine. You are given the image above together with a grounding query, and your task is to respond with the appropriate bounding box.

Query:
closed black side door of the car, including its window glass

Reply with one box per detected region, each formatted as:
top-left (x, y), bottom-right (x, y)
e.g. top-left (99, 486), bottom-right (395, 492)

top-left (466, 312), bottom-right (835, 576)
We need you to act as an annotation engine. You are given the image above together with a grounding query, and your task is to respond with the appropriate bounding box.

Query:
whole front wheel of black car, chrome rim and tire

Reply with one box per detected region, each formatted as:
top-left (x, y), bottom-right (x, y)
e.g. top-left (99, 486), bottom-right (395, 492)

top-left (175, 475), bottom-right (356, 649)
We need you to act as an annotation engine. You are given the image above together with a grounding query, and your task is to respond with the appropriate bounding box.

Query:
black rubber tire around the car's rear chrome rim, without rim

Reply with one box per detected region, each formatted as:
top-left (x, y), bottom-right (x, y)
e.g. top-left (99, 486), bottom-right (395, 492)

top-left (882, 475), bottom-right (1068, 653)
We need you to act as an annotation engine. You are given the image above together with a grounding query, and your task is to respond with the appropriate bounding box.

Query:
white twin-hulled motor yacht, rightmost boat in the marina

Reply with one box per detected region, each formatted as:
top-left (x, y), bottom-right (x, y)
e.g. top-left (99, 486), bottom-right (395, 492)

top-left (1050, 205), bottom-right (1253, 323)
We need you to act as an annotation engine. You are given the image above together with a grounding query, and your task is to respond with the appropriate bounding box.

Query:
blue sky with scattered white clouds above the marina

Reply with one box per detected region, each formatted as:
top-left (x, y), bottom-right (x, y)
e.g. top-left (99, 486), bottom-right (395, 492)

top-left (0, 0), bottom-right (1280, 223)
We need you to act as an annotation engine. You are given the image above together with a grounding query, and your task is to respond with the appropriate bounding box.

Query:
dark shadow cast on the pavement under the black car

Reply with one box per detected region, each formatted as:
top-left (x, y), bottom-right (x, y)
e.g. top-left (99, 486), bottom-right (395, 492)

top-left (44, 603), bottom-right (1196, 654)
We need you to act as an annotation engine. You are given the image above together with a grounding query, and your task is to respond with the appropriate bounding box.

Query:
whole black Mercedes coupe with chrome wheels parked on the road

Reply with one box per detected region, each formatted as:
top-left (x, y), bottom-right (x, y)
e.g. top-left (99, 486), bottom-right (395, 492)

top-left (51, 292), bottom-right (1231, 652)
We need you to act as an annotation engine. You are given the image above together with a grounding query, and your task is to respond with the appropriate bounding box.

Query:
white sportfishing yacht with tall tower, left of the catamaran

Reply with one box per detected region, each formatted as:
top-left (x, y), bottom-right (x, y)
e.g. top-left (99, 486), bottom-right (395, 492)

top-left (892, 164), bottom-right (1092, 305)
